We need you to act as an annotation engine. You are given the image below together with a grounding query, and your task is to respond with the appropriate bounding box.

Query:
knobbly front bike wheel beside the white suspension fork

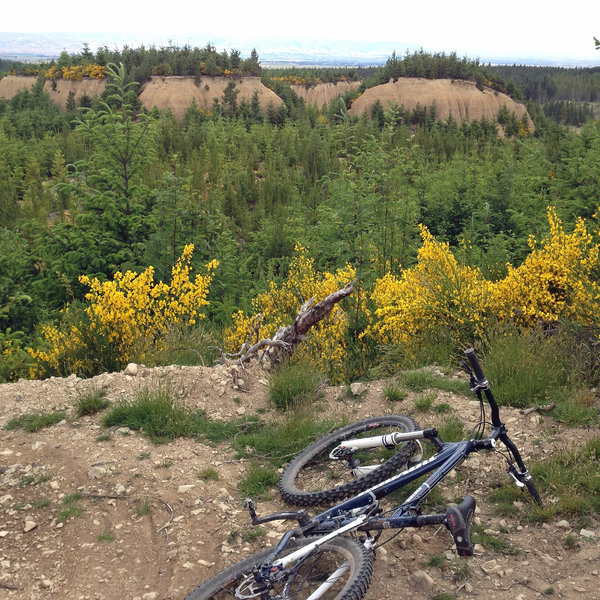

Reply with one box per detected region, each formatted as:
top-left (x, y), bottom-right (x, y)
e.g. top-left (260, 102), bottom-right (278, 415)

top-left (279, 415), bottom-right (420, 506)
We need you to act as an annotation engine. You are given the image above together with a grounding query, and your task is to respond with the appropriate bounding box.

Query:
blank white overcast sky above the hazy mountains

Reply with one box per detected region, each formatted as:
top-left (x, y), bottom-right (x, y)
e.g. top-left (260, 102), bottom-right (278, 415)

top-left (0, 0), bottom-right (600, 64)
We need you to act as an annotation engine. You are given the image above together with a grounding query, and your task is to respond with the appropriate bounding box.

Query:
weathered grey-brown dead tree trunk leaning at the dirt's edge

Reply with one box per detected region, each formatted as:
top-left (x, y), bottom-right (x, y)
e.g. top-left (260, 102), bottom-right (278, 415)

top-left (240, 282), bottom-right (354, 364)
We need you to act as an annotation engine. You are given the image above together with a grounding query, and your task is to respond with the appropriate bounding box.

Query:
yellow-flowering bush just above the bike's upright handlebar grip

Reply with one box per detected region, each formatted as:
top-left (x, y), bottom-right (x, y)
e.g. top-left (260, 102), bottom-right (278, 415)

top-left (368, 226), bottom-right (493, 350)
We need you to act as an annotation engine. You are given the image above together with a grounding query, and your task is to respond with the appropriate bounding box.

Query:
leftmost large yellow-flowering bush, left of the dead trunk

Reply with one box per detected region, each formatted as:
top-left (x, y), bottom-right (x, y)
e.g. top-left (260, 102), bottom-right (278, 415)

top-left (30, 244), bottom-right (218, 376)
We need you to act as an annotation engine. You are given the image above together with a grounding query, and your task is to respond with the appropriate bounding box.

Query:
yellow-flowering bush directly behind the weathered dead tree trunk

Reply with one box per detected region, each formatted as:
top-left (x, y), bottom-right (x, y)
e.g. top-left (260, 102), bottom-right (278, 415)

top-left (224, 244), bottom-right (356, 375)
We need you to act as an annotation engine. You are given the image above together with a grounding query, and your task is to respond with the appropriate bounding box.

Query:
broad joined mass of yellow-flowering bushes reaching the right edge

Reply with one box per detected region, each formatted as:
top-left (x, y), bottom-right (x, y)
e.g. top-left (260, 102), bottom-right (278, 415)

top-left (368, 208), bottom-right (600, 351)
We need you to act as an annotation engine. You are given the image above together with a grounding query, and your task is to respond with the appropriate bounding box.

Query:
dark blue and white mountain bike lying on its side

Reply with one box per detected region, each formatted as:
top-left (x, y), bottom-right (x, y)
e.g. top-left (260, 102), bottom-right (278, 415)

top-left (187, 349), bottom-right (541, 600)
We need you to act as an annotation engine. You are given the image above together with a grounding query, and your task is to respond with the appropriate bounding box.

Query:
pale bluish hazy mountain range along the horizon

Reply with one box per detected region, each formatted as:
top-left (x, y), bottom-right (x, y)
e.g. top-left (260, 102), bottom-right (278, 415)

top-left (0, 32), bottom-right (598, 67)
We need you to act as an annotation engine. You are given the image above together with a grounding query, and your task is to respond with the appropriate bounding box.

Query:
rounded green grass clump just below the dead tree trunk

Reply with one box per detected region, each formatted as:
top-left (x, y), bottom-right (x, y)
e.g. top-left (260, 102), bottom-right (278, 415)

top-left (269, 363), bottom-right (323, 411)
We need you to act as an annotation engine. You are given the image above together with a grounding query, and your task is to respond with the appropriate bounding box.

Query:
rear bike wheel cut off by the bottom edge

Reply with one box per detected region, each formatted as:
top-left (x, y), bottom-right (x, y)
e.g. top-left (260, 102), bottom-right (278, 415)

top-left (186, 536), bottom-right (373, 600)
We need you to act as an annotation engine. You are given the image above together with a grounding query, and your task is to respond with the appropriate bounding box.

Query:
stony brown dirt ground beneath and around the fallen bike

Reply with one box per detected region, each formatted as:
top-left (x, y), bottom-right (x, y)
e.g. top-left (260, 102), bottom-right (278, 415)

top-left (0, 366), bottom-right (600, 600)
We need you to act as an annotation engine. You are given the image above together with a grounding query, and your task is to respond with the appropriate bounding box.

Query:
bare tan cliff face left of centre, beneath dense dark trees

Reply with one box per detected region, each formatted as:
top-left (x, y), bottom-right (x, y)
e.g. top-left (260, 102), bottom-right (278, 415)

top-left (139, 77), bottom-right (283, 123)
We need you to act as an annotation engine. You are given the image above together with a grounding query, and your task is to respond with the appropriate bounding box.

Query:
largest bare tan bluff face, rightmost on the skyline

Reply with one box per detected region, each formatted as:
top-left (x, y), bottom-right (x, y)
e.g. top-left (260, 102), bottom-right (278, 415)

top-left (349, 77), bottom-right (527, 129)
